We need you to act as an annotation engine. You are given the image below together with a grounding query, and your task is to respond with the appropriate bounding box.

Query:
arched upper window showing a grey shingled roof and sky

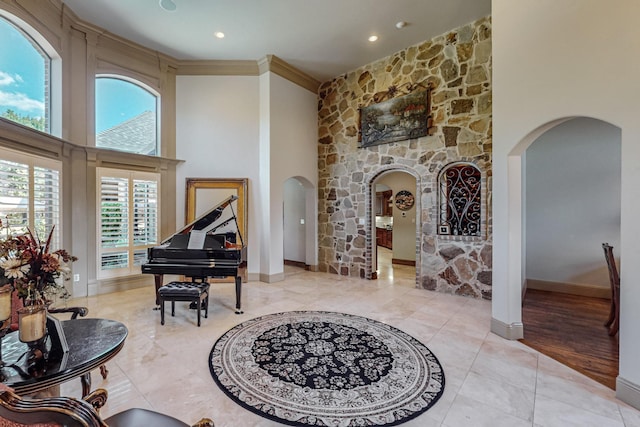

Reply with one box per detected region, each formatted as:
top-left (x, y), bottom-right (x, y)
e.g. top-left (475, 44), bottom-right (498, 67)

top-left (96, 76), bottom-right (159, 156)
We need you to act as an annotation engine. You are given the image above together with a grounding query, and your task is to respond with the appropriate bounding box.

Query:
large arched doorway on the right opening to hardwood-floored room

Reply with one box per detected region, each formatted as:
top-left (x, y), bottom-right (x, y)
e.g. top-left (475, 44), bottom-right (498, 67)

top-left (521, 117), bottom-right (621, 388)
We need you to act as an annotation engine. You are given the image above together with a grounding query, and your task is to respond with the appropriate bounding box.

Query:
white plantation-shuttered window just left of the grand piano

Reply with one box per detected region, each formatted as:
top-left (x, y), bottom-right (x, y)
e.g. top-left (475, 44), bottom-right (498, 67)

top-left (98, 168), bottom-right (160, 278)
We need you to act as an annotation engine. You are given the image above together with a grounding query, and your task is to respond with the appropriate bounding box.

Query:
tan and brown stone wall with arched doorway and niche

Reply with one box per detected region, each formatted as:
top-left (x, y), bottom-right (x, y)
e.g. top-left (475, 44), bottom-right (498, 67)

top-left (318, 17), bottom-right (492, 298)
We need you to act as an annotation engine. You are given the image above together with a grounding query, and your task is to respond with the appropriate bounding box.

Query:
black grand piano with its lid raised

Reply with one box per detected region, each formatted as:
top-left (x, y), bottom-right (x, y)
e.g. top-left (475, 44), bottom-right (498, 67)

top-left (142, 196), bottom-right (247, 313)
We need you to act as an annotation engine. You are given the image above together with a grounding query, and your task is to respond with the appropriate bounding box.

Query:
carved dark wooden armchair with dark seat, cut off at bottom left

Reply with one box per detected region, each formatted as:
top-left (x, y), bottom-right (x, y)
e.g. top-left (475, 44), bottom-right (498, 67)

top-left (0, 384), bottom-right (214, 427)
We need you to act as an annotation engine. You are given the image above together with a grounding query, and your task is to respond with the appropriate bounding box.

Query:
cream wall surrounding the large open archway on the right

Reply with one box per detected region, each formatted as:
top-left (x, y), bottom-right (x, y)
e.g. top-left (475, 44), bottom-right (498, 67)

top-left (492, 0), bottom-right (640, 407)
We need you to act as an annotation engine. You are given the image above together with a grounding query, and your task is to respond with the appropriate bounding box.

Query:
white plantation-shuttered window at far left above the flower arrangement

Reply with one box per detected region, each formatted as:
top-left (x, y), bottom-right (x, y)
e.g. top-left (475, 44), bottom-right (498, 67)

top-left (0, 150), bottom-right (62, 250)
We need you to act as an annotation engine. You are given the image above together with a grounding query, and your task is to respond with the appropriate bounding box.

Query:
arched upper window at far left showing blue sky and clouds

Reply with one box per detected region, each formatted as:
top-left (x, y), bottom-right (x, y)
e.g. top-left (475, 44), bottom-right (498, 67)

top-left (0, 15), bottom-right (52, 133)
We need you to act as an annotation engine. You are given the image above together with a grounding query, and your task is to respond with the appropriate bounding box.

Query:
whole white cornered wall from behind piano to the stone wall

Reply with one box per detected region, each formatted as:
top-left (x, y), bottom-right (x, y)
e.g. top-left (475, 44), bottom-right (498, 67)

top-left (176, 72), bottom-right (318, 281)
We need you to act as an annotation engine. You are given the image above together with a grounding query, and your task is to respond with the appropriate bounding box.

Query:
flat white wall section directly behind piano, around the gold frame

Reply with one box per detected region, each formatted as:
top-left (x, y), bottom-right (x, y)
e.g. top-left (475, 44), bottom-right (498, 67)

top-left (175, 76), bottom-right (261, 275)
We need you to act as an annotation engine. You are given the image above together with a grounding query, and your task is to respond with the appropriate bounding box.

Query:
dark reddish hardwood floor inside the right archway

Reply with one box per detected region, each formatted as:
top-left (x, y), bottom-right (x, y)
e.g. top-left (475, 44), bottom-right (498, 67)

top-left (520, 289), bottom-right (618, 390)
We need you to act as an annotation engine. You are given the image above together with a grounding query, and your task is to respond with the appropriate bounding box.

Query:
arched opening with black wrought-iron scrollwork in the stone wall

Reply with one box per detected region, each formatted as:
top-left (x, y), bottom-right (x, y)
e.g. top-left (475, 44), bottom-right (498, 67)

top-left (438, 162), bottom-right (482, 236)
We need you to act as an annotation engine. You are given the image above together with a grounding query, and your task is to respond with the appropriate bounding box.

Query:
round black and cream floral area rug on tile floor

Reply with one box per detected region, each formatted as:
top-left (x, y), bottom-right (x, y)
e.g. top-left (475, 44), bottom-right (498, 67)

top-left (209, 311), bottom-right (444, 426)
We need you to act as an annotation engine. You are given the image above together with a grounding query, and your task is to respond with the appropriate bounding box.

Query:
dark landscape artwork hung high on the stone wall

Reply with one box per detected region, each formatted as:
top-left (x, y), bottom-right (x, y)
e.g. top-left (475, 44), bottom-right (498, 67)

top-left (358, 84), bottom-right (431, 148)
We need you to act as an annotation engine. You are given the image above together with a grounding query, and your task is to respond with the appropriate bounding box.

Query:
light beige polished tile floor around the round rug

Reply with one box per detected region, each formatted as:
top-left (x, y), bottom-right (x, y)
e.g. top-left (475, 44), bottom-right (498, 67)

top-left (56, 249), bottom-right (640, 427)
